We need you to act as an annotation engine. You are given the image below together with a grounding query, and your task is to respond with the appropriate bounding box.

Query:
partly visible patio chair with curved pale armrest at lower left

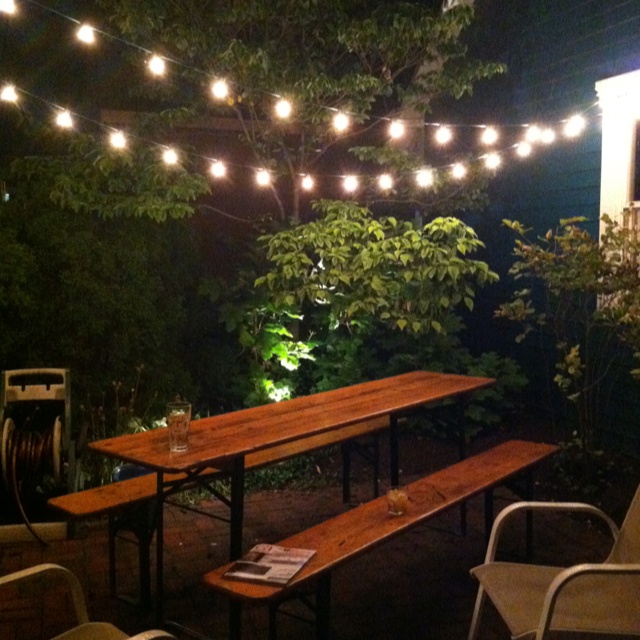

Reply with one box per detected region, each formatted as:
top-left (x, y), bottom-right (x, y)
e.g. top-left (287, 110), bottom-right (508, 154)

top-left (0, 564), bottom-right (176, 640)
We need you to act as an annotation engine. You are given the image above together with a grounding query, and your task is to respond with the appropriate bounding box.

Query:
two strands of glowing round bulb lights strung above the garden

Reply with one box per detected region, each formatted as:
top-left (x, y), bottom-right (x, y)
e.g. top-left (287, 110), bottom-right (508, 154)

top-left (0, 0), bottom-right (592, 193)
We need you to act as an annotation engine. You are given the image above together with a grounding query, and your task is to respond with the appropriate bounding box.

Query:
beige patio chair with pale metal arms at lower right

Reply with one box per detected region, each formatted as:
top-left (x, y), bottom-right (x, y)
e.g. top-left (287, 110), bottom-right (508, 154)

top-left (469, 487), bottom-right (640, 640)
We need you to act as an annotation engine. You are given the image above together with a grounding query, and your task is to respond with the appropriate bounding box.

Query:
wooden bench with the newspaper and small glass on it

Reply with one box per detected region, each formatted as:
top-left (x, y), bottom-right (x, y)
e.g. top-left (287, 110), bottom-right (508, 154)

top-left (204, 440), bottom-right (558, 640)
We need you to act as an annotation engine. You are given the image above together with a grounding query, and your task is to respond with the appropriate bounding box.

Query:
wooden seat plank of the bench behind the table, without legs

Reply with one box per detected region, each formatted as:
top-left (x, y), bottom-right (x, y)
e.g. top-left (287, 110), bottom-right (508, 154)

top-left (48, 416), bottom-right (389, 518)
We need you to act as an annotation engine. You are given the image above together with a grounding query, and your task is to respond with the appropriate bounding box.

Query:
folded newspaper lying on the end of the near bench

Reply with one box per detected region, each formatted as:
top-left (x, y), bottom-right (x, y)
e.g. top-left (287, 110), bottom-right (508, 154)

top-left (224, 544), bottom-right (315, 584)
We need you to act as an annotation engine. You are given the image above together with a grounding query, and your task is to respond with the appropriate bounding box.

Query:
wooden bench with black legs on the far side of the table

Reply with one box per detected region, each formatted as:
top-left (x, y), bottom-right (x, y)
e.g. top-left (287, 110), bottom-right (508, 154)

top-left (48, 416), bottom-right (389, 606)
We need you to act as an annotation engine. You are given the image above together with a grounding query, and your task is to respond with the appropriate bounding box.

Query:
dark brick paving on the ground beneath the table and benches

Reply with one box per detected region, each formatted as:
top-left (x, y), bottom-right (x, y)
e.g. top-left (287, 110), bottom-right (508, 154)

top-left (0, 441), bottom-right (609, 640)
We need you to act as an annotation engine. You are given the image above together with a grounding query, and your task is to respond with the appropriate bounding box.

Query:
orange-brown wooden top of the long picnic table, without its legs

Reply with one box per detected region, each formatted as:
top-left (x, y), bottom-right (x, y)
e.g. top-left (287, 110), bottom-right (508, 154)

top-left (89, 371), bottom-right (495, 472)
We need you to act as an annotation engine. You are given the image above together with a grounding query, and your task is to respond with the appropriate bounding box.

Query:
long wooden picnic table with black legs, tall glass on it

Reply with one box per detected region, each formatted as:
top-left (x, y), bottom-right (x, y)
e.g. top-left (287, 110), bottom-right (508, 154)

top-left (89, 371), bottom-right (495, 617)
